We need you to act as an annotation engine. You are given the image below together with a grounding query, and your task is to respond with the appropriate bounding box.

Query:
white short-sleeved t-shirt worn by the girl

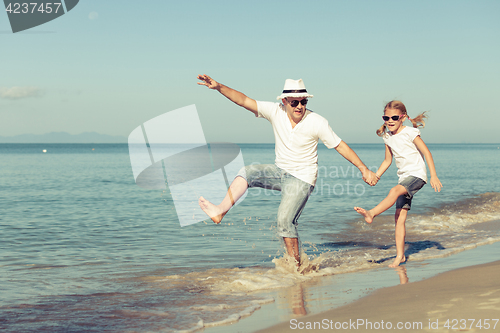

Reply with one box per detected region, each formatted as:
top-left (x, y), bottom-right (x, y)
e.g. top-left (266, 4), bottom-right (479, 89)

top-left (383, 126), bottom-right (427, 183)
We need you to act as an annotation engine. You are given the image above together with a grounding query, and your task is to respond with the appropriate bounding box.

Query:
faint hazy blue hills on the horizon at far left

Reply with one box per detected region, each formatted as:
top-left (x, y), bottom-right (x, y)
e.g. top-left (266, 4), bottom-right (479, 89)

top-left (0, 132), bottom-right (127, 143)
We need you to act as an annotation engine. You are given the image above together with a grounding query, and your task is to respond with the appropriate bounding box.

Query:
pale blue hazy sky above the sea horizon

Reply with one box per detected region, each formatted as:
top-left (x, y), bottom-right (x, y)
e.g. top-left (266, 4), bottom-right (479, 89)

top-left (0, 0), bottom-right (500, 143)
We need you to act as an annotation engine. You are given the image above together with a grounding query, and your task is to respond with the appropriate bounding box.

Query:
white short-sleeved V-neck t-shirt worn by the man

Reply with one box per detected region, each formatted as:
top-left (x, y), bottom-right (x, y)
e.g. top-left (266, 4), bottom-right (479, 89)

top-left (257, 101), bottom-right (342, 185)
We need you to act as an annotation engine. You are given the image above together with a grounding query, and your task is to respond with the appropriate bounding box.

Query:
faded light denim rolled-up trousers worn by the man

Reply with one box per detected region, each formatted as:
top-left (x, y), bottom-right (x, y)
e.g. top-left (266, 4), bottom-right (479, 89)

top-left (238, 164), bottom-right (314, 238)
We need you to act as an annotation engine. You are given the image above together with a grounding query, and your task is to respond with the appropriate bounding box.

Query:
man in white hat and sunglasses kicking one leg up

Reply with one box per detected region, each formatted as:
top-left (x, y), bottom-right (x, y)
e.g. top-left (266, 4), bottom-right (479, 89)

top-left (198, 75), bottom-right (376, 266)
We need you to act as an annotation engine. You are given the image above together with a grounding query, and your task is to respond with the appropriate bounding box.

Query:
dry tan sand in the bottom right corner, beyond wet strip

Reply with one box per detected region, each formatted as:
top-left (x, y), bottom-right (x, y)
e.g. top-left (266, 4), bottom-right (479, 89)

top-left (258, 261), bottom-right (500, 332)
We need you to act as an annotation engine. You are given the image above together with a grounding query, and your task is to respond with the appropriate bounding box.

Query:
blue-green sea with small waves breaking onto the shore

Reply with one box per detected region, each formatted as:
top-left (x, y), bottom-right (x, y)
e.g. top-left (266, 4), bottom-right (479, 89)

top-left (0, 143), bottom-right (500, 332)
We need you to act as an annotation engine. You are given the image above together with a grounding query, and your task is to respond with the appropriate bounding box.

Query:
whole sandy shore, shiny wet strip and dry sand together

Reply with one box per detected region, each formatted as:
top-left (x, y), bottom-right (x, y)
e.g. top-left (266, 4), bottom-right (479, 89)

top-left (205, 220), bottom-right (500, 333)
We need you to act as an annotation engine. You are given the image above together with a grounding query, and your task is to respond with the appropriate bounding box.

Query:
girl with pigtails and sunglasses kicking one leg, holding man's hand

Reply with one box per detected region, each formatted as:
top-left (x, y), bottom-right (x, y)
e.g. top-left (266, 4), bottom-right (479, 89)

top-left (354, 101), bottom-right (443, 267)
